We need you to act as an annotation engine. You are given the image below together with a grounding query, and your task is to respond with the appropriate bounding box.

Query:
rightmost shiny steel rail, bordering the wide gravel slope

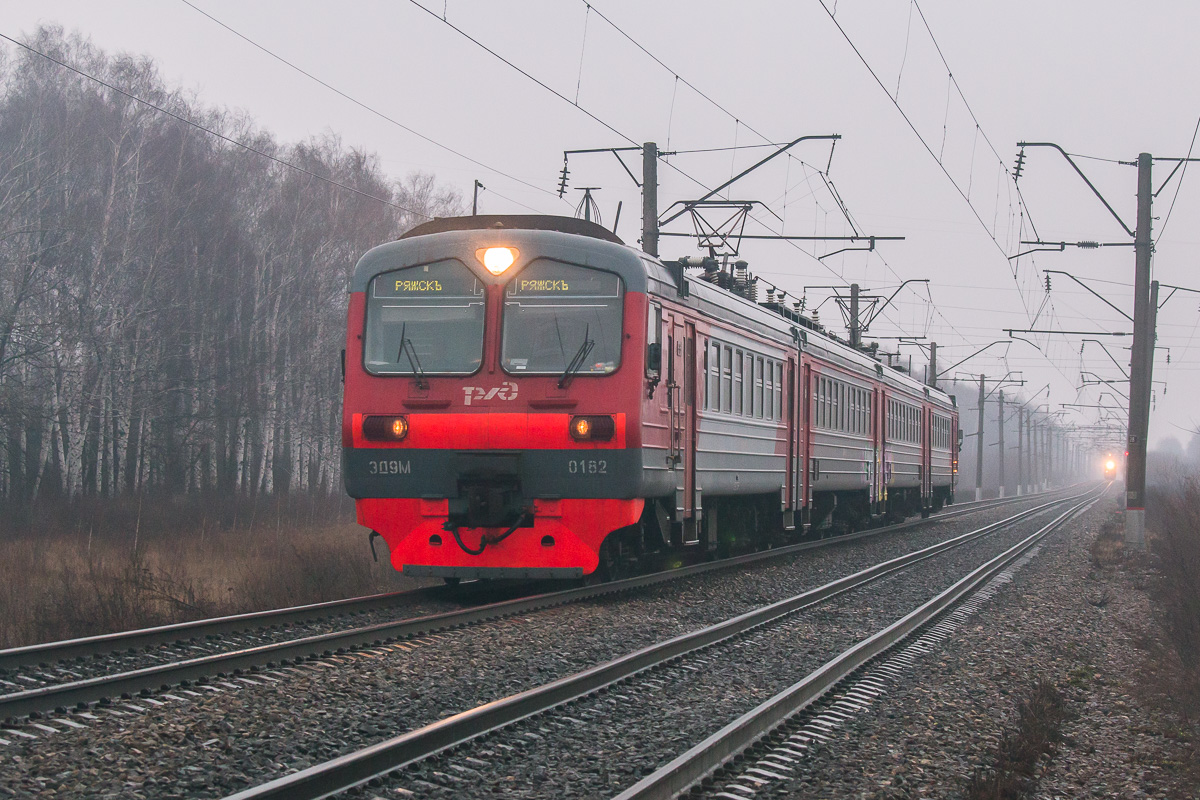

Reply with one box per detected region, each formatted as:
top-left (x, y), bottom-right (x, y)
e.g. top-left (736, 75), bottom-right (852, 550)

top-left (613, 492), bottom-right (1103, 800)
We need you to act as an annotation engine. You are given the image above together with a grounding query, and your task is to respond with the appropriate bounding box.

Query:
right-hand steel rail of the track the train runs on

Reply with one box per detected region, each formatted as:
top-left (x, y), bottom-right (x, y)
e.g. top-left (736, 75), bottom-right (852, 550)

top-left (0, 484), bottom-right (1075, 718)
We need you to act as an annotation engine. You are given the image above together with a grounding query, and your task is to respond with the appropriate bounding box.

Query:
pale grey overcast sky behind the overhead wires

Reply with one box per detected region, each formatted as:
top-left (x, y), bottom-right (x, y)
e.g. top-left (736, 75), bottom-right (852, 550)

top-left (0, 0), bottom-right (1200, 455)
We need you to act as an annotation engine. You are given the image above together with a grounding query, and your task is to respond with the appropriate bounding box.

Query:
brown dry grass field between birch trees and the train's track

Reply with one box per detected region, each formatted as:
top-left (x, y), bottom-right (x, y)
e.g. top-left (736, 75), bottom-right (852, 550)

top-left (0, 498), bottom-right (432, 648)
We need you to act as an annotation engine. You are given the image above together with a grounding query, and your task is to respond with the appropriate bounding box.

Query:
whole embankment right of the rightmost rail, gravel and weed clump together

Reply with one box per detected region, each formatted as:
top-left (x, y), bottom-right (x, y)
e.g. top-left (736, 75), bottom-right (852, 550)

top-left (762, 499), bottom-right (1200, 800)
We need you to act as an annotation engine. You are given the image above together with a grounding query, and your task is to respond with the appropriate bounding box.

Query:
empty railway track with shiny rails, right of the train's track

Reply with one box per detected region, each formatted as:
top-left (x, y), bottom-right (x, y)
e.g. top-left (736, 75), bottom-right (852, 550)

top-left (218, 491), bottom-right (1100, 800)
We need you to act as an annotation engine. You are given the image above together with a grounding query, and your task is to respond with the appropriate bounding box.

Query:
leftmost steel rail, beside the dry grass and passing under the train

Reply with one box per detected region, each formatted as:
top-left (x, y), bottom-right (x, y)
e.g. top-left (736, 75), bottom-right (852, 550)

top-left (0, 489), bottom-right (1066, 672)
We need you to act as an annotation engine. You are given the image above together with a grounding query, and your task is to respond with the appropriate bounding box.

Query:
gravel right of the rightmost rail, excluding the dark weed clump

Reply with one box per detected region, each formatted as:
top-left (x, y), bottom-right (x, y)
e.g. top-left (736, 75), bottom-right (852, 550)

top-left (707, 498), bottom-right (1200, 800)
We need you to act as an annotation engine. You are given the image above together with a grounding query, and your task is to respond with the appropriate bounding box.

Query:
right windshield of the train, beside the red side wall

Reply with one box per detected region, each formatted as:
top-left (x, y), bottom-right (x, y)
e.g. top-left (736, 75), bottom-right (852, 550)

top-left (500, 259), bottom-right (622, 375)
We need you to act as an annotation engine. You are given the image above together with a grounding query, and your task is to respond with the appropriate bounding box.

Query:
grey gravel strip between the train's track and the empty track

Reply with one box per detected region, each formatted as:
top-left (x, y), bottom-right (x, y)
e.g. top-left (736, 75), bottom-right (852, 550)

top-left (0, 491), bottom-right (1089, 796)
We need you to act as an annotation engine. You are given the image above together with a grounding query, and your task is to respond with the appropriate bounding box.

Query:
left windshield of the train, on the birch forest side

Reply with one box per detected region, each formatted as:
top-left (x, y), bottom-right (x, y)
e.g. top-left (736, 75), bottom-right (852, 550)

top-left (364, 260), bottom-right (484, 375)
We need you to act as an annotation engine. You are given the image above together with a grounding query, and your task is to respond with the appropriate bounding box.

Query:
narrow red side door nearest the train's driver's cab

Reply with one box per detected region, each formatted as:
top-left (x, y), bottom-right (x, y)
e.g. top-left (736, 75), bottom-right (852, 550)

top-left (667, 313), bottom-right (701, 545)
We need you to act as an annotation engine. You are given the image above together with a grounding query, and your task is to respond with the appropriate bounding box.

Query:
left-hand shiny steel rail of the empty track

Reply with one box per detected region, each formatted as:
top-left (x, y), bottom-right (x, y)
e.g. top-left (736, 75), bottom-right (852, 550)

top-left (216, 489), bottom-right (1094, 800)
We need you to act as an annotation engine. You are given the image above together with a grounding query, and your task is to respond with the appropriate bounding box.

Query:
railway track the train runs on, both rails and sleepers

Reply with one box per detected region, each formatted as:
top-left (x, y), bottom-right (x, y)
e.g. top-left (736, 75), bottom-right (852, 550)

top-left (0, 484), bottom-right (1070, 724)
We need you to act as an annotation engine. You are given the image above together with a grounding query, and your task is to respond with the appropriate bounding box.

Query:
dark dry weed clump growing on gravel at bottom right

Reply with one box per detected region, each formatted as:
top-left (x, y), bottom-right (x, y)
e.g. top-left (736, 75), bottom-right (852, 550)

top-left (964, 679), bottom-right (1067, 800)
